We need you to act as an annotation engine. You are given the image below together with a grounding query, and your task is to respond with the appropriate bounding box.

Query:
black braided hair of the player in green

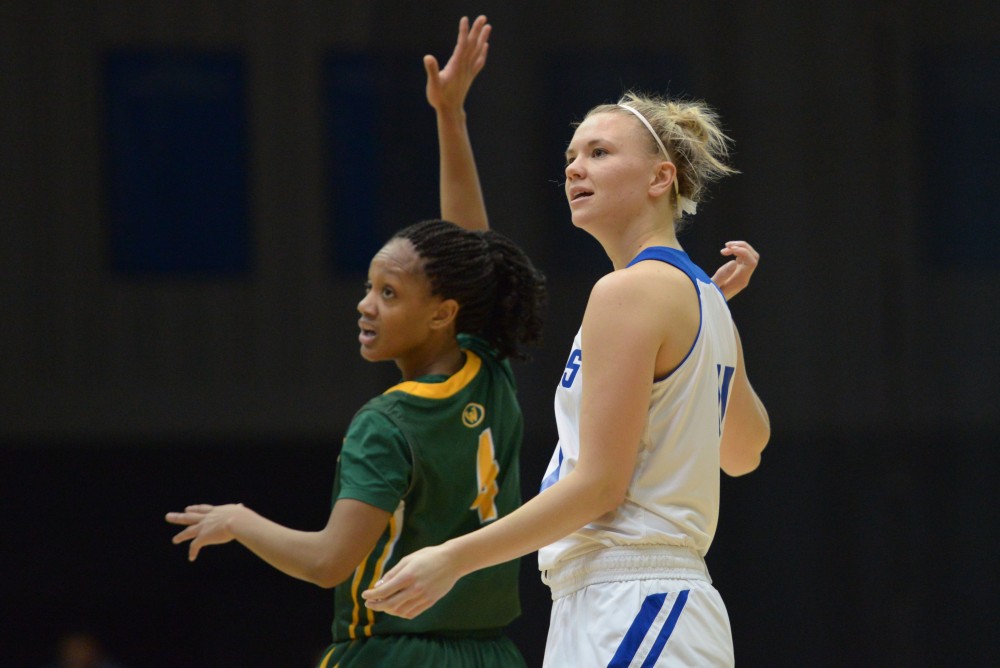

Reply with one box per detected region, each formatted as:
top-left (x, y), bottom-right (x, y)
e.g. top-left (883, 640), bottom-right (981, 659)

top-left (393, 220), bottom-right (548, 359)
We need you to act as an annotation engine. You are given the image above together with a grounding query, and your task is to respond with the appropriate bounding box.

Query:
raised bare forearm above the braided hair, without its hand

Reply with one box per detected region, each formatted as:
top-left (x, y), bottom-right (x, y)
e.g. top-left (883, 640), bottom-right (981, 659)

top-left (437, 109), bottom-right (489, 230)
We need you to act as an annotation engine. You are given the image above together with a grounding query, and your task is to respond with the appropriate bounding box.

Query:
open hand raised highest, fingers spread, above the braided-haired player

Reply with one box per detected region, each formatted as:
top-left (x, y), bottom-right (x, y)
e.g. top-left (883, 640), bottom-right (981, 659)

top-left (424, 16), bottom-right (492, 111)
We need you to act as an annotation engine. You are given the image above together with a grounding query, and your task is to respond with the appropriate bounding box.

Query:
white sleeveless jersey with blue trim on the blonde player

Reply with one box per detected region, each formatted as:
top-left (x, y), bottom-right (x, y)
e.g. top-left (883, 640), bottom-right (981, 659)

top-left (539, 247), bottom-right (737, 571)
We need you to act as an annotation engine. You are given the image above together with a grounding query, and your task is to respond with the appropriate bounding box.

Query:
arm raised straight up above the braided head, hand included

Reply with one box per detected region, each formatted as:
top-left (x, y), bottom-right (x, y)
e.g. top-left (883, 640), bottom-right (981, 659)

top-left (424, 16), bottom-right (491, 230)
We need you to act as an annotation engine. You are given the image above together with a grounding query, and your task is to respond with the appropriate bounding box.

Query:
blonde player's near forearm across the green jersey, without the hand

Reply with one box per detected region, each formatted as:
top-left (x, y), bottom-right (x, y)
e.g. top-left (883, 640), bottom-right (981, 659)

top-left (445, 471), bottom-right (613, 575)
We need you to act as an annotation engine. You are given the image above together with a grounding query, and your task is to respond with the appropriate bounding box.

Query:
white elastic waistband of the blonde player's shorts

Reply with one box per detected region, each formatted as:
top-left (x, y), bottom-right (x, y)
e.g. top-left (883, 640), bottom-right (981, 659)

top-left (542, 545), bottom-right (712, 600)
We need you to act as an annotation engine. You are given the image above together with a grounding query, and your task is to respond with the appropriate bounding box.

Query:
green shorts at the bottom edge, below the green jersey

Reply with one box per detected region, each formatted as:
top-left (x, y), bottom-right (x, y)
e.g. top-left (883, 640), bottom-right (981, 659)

top-left (319, 635), bottom-right (527, 668)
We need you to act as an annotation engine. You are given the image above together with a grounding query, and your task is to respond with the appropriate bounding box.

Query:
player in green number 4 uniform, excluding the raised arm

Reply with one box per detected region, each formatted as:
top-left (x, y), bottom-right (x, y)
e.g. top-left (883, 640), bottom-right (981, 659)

top-left (166, 221), bottom-right (545, 668)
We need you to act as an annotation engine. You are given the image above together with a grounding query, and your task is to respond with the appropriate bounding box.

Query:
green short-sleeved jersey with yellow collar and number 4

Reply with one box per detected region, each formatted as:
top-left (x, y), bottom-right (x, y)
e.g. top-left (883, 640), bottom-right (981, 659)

top-left (333, 336), bottom-right (523, 642)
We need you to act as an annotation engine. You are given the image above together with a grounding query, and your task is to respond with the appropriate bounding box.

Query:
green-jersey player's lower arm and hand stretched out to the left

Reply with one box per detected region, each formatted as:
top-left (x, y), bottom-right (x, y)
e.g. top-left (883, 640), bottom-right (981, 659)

top-left (166, 499), bottom-right (389, 587)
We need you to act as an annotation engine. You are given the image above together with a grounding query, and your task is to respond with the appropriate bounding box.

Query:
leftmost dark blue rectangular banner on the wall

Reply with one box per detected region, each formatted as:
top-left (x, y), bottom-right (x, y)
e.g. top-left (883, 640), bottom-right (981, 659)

top-left (104, 51), bottom-right (251, 277)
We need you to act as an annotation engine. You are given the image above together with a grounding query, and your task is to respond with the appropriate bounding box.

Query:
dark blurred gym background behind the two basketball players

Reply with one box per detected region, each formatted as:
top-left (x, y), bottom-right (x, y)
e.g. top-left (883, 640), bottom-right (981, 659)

top-left (0, 0), bottom-right (1000, 668)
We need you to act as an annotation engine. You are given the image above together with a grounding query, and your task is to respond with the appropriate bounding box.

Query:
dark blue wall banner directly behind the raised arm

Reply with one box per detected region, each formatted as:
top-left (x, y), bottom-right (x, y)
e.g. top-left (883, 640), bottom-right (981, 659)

top-left (324, 51), bottom-right (440, 275)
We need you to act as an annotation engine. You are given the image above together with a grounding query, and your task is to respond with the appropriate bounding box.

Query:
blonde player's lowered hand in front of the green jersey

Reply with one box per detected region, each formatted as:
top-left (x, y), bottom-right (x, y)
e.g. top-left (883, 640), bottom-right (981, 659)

top-left (361, 545), bottom-right (459, 619)
